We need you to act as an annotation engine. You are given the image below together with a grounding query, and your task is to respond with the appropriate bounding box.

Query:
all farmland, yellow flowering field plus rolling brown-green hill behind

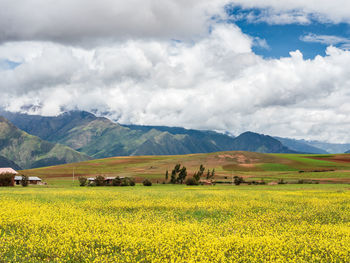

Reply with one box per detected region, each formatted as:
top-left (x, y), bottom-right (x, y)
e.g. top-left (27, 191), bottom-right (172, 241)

top-left (0, 152), bottom-right (350, 262)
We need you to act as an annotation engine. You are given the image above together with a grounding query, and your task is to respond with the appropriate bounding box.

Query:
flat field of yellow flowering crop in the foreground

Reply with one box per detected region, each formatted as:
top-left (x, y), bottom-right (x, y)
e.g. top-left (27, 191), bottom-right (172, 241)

top-left (0, 184), bottom-right (350, 262)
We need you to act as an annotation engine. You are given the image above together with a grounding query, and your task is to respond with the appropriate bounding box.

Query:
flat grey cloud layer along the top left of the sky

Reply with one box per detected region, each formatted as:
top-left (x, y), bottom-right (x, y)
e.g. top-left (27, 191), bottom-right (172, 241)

top-left (0, 0), bottom-right (228, 46)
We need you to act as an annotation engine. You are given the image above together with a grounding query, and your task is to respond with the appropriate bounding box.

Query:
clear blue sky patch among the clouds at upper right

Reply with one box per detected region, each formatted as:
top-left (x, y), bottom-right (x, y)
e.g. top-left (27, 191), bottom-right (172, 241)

top-left (226, 6), bottom-right (350, 59)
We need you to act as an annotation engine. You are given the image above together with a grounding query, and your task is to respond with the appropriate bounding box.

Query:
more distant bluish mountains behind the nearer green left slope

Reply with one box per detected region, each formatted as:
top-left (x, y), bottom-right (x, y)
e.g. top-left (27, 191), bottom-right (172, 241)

top-left (4, 111), bottom-right (294, 158)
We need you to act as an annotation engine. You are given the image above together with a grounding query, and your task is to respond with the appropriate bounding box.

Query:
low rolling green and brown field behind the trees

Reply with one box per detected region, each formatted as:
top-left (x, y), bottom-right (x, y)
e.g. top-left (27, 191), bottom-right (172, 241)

top-left (22, 152), bottom-right (350, 186)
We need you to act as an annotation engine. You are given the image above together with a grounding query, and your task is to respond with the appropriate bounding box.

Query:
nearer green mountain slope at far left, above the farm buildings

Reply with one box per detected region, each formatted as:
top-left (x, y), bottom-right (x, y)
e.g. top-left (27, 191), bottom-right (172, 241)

top-left (0, 117), bottom-right (90, 169)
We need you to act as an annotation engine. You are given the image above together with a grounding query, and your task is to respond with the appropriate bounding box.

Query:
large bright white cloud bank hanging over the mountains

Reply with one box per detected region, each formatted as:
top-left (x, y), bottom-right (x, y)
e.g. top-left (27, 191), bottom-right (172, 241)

top-left (0, 24), bottom-right (350, 142)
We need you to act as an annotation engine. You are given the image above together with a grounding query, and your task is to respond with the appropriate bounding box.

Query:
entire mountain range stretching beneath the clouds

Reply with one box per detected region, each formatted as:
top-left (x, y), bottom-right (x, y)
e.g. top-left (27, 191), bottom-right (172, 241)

top-left (0, 111), bottom-right (350, 169)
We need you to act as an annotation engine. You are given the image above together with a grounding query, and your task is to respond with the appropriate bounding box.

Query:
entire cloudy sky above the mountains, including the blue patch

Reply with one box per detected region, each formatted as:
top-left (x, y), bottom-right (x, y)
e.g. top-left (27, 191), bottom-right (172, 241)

top-left (0, 0), bottom-right (350, 143)
